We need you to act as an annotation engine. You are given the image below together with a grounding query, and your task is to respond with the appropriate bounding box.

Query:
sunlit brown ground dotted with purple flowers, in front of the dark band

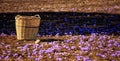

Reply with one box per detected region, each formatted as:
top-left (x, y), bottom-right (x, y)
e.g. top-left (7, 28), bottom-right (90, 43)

top-left (0, 33), bottom-right (120, 61)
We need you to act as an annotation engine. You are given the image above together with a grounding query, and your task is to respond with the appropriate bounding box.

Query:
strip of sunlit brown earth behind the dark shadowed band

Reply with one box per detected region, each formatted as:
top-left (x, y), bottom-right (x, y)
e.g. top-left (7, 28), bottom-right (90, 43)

top-left (0, 0), bottom-right (120, 14)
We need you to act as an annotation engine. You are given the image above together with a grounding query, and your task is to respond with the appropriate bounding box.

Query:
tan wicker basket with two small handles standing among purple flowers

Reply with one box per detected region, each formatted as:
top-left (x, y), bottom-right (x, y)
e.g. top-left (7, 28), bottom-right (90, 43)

top-left (15, 15), bottom-right (40, 40)
